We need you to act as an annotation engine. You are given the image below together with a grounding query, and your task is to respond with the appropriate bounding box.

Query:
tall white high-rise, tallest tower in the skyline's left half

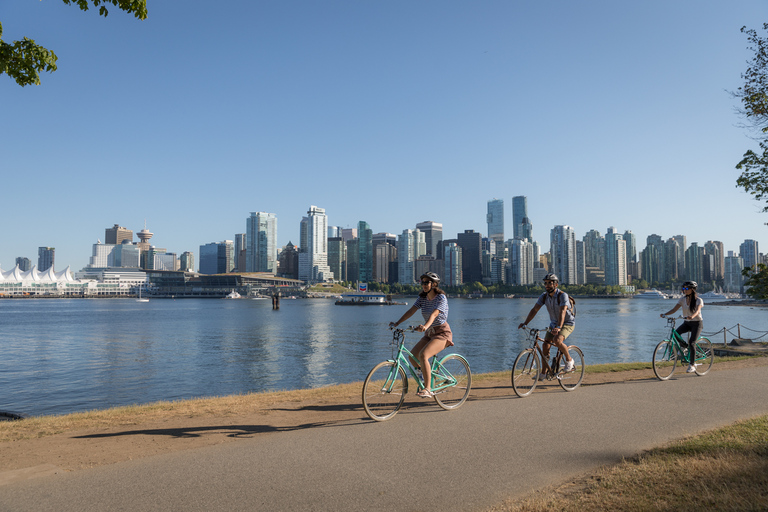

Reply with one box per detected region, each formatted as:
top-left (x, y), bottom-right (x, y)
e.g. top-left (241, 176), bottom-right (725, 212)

top-left (299, 205), bottom-right (332, 284)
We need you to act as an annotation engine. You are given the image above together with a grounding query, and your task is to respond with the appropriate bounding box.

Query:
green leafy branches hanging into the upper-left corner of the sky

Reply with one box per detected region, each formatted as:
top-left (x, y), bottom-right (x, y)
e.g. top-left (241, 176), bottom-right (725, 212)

top-left (0, 0), bottom-right (147, 87)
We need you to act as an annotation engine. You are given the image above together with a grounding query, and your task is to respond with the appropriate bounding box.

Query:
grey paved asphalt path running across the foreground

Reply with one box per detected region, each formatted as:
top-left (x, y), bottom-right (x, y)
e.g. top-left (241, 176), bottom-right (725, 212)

top-left (0, 367), bottom-right (768, 512)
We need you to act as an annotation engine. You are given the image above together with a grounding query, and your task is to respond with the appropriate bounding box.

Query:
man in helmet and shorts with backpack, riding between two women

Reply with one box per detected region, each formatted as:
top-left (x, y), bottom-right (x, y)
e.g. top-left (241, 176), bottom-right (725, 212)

top-left (517, 273), bottom-right (575, 378)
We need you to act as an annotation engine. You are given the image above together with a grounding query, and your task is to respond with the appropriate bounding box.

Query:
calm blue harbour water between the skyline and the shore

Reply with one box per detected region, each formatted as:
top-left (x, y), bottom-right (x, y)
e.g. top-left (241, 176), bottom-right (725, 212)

top-left (0, 298), bottom-right (768, 415)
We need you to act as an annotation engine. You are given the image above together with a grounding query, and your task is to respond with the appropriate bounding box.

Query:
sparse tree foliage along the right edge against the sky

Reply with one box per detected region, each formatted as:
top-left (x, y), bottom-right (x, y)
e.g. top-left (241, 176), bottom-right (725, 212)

top-left (734, 23), bottom-right (768, 212)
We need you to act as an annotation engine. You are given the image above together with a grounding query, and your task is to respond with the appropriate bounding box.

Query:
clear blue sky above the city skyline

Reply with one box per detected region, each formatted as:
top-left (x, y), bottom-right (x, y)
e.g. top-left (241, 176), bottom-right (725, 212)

top-left (0, 0), bottom-right (768, 270)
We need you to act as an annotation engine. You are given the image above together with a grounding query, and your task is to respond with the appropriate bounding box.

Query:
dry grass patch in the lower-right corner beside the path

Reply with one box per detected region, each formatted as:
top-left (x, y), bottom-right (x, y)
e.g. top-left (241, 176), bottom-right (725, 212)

top-left (492, 416), bottom-right (768, 512)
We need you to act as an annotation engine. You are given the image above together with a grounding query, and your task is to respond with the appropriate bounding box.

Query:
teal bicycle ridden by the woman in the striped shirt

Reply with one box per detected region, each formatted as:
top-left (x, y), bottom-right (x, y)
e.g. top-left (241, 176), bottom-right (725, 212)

top-left (363, 327), bottom-right (472, 421)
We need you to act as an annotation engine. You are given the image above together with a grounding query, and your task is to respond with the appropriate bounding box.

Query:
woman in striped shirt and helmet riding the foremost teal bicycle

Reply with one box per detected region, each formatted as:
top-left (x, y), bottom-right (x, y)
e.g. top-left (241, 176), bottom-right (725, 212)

top-left (389, 272), bottom-right (453, 398)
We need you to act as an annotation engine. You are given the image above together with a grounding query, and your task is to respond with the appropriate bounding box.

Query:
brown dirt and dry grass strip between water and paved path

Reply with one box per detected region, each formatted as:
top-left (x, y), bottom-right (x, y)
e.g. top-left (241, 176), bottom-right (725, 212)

top-left (0, 357), bottom-right (768, 485)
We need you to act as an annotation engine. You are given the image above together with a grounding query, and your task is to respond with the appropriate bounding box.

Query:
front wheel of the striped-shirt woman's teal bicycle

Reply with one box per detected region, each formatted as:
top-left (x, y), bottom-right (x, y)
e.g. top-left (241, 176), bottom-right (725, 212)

top-left (363, 361), bottom-right (408, 421)
